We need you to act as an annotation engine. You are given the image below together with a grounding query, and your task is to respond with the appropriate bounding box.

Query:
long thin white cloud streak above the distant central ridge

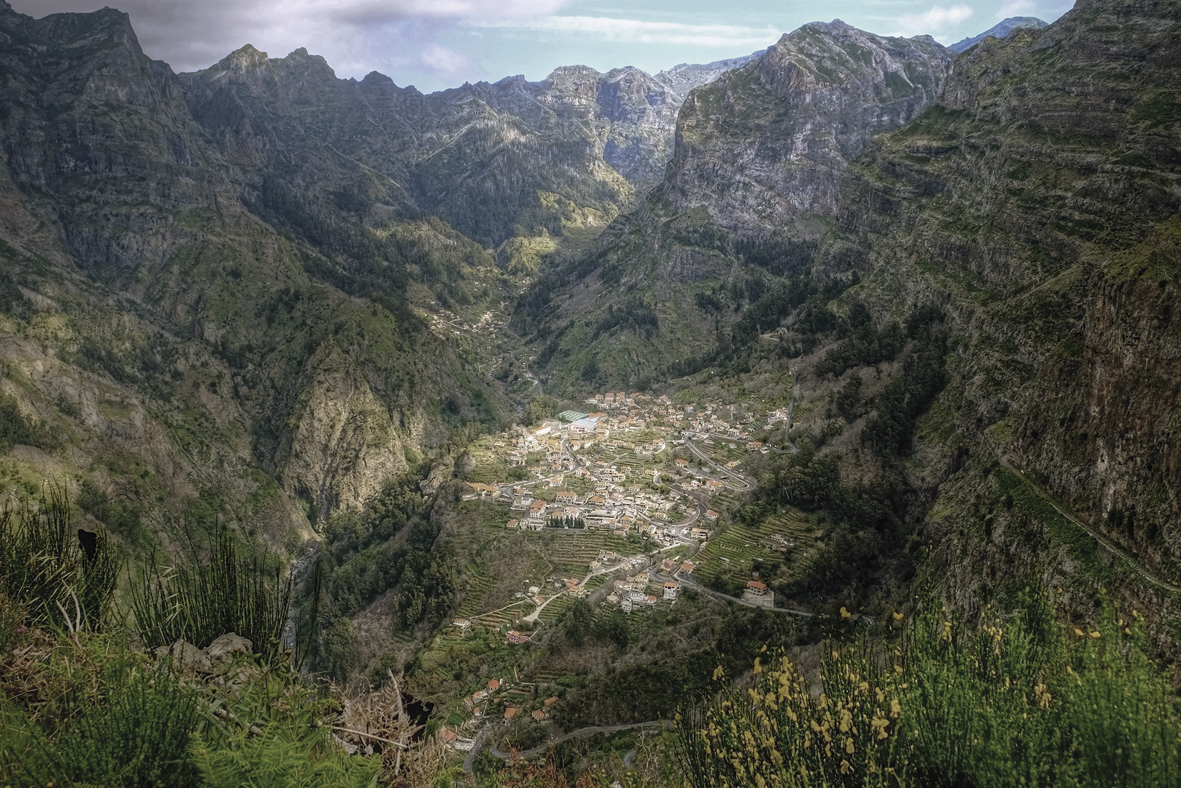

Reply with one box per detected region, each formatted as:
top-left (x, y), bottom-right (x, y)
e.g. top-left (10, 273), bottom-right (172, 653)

top-left (469, 17), bottom-right (779, 47)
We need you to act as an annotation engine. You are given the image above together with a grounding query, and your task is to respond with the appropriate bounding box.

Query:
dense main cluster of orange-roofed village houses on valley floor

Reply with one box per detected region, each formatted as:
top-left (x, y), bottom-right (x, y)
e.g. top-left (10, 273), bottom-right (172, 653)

top-left (465, 392), bottom-right (787, 547)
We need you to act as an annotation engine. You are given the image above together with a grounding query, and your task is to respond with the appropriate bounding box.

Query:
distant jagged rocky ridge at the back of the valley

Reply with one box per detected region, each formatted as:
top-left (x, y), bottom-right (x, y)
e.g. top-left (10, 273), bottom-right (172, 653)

top-left (184, 46), bottom-right (742, 246)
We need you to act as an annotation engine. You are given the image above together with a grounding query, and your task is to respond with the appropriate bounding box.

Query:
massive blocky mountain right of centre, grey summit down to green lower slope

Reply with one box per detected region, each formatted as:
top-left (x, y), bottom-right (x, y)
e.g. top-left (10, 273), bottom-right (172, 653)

top-left (518, 20), bottom-right (953, 388)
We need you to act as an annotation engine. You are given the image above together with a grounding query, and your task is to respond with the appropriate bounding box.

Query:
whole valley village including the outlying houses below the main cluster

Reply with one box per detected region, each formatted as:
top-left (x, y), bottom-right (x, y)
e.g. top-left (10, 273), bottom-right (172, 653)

top-left (434, 392), bottom-right (812, 750)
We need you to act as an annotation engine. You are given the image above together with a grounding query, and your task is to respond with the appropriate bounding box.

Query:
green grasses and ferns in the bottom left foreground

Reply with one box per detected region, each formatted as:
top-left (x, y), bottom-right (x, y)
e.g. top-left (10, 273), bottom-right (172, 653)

top-left (0, 494), bottom-right (448, 787)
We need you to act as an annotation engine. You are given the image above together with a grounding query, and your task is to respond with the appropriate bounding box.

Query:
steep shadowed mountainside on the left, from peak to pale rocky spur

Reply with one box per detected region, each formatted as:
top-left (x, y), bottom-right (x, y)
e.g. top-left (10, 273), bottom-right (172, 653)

top-left (0, 6), bottom-right (504, 532)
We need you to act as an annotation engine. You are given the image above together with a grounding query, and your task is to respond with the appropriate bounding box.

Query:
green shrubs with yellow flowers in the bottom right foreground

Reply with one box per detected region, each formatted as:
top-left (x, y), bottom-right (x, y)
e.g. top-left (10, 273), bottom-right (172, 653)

top-left (678, 600), bottom-right (1181, 788)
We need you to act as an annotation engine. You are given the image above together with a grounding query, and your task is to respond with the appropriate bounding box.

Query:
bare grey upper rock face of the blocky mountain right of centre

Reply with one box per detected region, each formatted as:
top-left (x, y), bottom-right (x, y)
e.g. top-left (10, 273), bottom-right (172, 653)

top-left (663, 20), bottom-right (953, 236)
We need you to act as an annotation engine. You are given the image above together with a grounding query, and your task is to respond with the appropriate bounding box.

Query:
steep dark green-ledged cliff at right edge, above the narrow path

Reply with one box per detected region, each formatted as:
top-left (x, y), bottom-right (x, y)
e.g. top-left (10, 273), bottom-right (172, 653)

top-left (818, 0), bottom-right (1181, 590)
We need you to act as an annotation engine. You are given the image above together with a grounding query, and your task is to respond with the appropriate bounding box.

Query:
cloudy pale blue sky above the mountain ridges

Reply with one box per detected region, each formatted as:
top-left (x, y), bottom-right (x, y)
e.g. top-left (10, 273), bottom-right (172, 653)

top-left (9, 0), bottom-right (1074, 92)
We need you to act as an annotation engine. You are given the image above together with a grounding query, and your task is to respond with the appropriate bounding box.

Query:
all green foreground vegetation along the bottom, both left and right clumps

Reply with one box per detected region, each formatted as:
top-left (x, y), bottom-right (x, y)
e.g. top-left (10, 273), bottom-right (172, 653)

top-left (9, 484), bottom-right (1181, 788)
